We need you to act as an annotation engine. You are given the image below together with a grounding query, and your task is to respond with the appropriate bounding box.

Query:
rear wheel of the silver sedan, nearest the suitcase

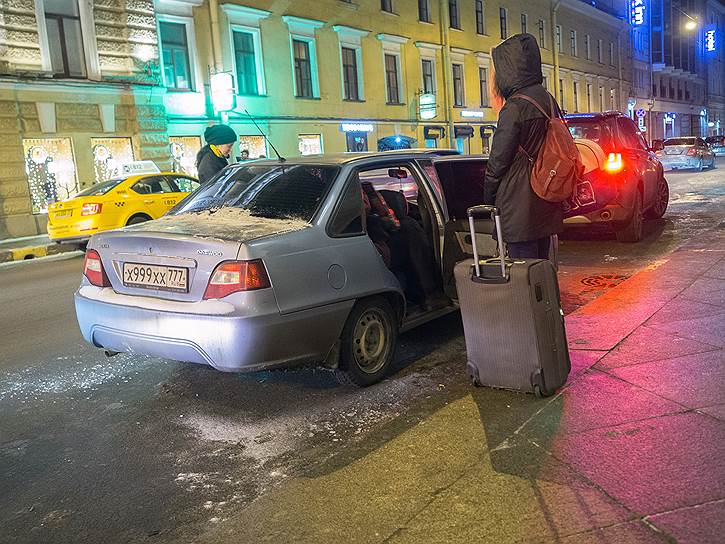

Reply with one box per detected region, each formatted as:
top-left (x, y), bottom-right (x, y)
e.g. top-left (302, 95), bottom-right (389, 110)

top-left (335, 297), bottom-right (398, 387)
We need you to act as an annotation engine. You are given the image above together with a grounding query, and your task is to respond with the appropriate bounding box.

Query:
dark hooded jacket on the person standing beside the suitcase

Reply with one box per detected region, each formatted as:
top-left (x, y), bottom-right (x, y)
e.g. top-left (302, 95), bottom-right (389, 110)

top-left (483, 34), bottom-right (564, 242)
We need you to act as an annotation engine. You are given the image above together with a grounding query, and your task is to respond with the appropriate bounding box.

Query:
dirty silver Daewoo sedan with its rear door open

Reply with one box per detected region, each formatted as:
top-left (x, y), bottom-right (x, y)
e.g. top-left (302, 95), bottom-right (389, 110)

top-left (75, 151), bottom-right (490, 386)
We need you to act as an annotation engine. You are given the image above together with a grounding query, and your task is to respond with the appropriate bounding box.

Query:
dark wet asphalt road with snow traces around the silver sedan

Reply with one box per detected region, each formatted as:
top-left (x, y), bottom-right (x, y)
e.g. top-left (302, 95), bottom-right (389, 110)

top-left (0, 159), bottom-right (725, 543)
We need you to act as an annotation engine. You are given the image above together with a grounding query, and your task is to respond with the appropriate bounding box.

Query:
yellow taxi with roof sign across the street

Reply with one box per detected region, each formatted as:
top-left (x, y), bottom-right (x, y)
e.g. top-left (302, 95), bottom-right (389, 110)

top-left (48, 161), bottom-right (199, 242)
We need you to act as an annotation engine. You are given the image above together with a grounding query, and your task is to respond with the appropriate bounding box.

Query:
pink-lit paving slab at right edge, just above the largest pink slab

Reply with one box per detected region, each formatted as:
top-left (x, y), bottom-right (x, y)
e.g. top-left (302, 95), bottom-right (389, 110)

top-left (610, 350), bottom-right (725, 408)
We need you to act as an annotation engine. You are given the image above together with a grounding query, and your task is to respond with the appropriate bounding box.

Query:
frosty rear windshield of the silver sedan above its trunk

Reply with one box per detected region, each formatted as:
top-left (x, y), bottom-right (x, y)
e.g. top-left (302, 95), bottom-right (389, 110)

top-left (171, 164), bottom-right (340, 221)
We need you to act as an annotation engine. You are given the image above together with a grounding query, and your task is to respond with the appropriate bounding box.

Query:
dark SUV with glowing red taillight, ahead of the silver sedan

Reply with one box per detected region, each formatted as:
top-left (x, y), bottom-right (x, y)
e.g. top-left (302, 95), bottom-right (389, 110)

top-left (565, 111), bottom-right (670, 242)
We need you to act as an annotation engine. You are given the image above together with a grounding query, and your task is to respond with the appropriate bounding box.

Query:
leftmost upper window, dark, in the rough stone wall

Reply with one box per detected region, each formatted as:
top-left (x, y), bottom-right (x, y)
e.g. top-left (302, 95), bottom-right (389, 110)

top-left (45, 2), bottom-right (86, 77)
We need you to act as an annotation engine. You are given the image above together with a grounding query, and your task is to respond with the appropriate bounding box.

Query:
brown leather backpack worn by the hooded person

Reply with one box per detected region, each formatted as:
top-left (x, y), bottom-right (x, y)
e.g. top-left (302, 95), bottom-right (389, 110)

top-left (511, 94), bottom-right (584, 202)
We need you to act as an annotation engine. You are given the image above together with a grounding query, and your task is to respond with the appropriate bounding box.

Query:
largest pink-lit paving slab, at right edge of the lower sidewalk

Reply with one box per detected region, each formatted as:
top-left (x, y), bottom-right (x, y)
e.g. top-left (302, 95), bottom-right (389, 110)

top-left (551, 412), bottom-right (725, 515)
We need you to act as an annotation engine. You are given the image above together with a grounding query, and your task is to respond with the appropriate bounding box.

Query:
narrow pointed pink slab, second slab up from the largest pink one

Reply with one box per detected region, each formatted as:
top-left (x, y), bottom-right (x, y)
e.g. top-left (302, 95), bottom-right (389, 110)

top-left (595, 327), bottom-right (718, 369)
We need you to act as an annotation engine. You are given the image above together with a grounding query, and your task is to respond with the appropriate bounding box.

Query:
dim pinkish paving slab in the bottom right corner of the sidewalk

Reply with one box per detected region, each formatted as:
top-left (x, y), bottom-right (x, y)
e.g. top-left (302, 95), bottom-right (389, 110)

top-left (648, 500), bottom-right (725, 544)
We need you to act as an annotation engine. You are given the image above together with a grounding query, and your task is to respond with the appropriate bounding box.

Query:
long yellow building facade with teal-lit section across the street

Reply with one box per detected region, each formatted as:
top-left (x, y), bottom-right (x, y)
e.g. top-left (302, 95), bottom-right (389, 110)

top-left (0, 0), bottom-right (634, 238)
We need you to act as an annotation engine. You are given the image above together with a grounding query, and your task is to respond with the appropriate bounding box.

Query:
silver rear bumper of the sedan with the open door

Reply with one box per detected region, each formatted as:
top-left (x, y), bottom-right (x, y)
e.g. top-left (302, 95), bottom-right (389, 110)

top-left (75, 286), bottom-right (353, 372)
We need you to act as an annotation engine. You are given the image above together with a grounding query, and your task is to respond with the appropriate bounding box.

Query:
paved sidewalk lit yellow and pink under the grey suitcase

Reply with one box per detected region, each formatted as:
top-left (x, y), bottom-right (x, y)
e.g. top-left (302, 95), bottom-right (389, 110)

top-left (199, 225), bottom-right (725, 544)
